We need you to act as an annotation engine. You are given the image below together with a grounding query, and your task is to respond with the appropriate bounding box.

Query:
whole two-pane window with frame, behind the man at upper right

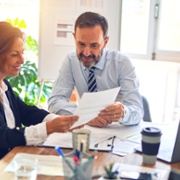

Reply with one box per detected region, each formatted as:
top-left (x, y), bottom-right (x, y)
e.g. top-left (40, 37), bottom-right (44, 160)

top-left (120, 0), bottom-right (180, 62)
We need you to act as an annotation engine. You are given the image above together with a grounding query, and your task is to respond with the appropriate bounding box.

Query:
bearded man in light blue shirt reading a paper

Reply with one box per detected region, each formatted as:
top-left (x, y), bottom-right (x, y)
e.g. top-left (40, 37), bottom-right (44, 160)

top-left (48, 12), bottom-right (143, 127)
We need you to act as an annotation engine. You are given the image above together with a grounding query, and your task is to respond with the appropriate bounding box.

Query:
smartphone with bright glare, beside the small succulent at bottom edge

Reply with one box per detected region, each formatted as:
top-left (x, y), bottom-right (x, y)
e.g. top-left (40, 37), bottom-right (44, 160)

top-left (120, 171), bottom-right (153, 180)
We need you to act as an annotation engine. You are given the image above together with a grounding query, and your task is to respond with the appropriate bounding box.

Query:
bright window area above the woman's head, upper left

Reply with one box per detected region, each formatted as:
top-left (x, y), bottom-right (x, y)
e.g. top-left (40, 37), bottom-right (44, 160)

top-left (0, 0), bottom-right (39, 40)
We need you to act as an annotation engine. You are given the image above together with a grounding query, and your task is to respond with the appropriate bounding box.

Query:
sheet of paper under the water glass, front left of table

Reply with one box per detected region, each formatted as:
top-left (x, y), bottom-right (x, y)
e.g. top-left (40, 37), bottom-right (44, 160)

top-left (5, 153), bottom-right (64, 176)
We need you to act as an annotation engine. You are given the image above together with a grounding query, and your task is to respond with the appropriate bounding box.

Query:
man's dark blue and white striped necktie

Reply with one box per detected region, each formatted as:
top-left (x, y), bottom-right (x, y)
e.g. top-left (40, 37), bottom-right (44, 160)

top-left (88, 66), bottom-right (97, 92)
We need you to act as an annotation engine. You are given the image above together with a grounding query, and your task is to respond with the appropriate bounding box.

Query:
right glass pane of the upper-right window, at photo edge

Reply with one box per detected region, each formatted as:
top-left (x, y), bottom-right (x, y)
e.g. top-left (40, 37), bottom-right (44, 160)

top-left (156, 0), bottom-right (180, 61)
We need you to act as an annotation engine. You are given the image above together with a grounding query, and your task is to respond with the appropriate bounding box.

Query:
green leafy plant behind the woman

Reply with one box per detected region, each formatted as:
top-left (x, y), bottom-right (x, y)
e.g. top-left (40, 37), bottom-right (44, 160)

top-left (6, 18), bottom-right (52, 105)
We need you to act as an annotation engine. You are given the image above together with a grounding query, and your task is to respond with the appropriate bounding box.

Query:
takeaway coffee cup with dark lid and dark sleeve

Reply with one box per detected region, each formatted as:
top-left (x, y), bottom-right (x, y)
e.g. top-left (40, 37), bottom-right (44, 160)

top-left (141, 127), bottom-right (162, 165)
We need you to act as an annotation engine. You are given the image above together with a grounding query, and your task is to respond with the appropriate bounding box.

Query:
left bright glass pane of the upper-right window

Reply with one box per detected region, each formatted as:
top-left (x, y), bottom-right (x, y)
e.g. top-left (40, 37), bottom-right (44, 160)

top-left (120, 0), bottom-right (150, 55)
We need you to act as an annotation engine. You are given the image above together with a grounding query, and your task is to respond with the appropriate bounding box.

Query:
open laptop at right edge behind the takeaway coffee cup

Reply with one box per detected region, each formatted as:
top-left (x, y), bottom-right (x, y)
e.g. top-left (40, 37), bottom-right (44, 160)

top-left (135, 121), bottom-right (180, 163)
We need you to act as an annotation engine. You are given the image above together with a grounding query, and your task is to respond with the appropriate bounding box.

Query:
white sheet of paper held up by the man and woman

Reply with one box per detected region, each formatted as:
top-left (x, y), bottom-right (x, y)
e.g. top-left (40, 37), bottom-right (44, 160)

top-left (72, 87), bottom-right (120, 128)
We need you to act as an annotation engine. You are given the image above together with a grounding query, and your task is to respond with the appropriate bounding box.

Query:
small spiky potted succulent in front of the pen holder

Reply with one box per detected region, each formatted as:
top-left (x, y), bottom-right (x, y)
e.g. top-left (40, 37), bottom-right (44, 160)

top-left (103, 163), bottom-right (119, 179)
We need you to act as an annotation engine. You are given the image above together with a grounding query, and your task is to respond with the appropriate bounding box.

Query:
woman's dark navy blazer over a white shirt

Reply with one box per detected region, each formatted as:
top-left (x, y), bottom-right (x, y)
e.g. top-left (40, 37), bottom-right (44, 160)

top-left (0, 80), bottom-right (49, 159)
